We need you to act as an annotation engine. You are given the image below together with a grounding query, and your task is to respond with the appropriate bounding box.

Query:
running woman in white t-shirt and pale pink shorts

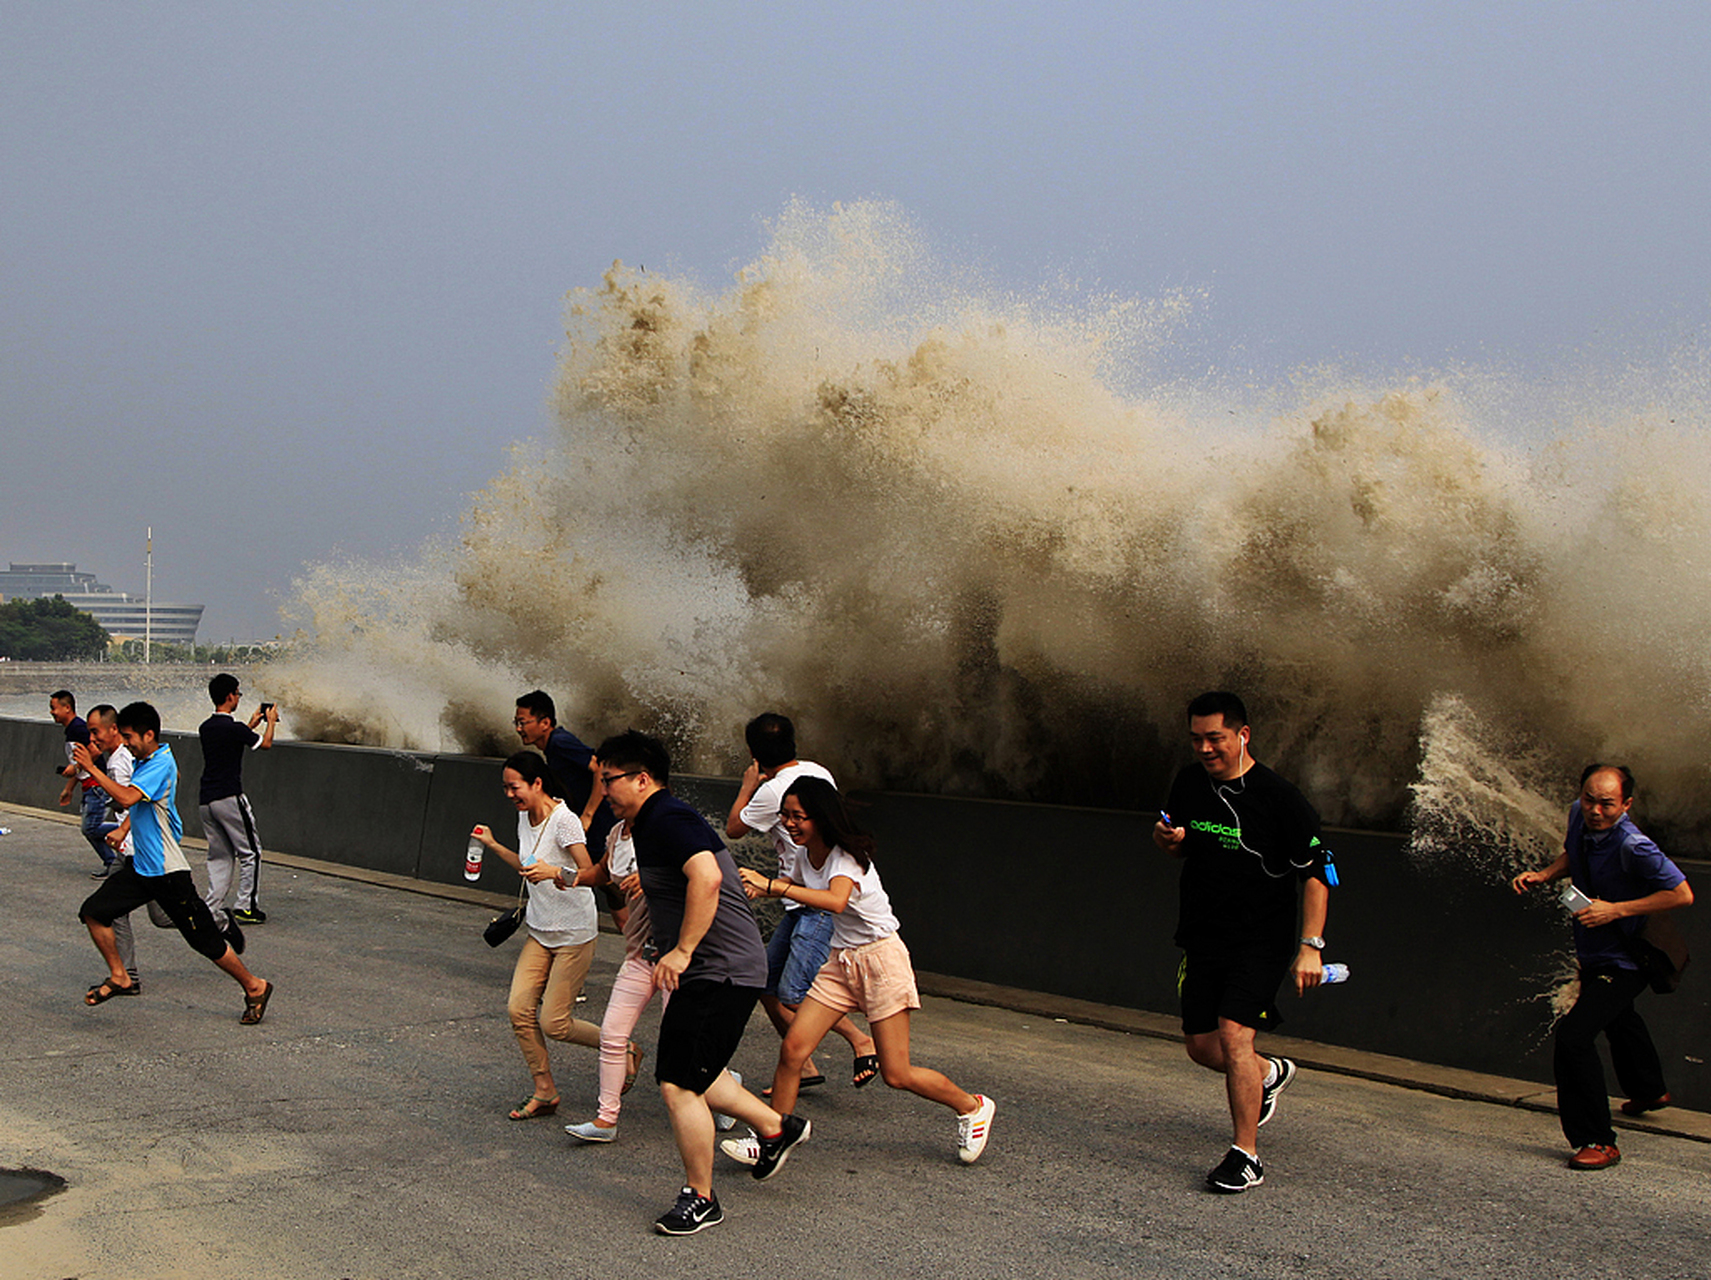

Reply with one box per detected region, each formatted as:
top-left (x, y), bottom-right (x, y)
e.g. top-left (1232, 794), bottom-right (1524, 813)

top-left (739, 777), bottom-right (998, 1176)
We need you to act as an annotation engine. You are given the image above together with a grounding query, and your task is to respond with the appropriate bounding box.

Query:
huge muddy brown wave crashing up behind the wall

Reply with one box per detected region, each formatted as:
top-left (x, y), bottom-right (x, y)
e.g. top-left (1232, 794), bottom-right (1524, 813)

top-left (287, 204), bottom-right (1711, 837)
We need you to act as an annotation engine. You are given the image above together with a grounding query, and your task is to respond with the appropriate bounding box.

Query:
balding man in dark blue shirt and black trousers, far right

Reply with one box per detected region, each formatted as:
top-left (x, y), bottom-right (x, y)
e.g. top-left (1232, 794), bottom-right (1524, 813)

top-left (1511, 763), bottom-right (1694, 1169)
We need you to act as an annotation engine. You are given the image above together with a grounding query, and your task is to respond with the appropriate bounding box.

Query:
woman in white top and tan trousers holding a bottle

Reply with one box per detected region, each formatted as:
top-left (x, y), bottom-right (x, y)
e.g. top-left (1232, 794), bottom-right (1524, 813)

top-left (474, 751), bottom-right (601, 1121)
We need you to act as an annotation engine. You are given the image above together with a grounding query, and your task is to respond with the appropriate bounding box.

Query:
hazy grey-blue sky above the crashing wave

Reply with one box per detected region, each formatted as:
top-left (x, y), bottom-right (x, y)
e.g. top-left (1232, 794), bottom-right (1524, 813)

top-left (0, 0), bottom-right (1711, 640)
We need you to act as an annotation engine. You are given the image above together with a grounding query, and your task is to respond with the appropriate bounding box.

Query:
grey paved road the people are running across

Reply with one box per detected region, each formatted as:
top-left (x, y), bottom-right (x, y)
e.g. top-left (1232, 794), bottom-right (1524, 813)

top-left (0, 811), bottom-right (1711, 1280)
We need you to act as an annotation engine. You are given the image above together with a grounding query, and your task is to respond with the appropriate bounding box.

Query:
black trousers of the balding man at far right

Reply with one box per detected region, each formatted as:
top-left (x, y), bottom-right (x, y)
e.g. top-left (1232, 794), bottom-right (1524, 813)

top-left (1554, 969), bottom-right (1667, 1147)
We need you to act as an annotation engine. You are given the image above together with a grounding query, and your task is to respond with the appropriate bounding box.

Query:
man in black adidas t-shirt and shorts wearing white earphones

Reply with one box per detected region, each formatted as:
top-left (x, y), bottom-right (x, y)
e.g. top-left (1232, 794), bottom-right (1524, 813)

top-left (1153, 693), bottom-right (1329, 1194)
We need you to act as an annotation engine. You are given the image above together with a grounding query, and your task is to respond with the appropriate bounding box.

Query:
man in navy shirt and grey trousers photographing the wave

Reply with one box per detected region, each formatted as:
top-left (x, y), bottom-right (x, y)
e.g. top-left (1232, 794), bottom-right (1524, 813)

top-left (197, 671), bottom-right (279, 924)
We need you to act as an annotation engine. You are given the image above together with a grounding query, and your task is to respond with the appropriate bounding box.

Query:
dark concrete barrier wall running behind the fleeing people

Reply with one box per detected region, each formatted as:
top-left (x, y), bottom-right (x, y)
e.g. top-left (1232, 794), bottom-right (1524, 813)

top-left (0, 719), bottom-right (1711, 1111)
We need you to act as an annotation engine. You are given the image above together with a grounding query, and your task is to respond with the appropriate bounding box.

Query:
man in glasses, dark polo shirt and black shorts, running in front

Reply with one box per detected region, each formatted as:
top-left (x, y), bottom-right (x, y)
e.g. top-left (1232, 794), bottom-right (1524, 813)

top-left (595, 729), bottom-right (793, 1236)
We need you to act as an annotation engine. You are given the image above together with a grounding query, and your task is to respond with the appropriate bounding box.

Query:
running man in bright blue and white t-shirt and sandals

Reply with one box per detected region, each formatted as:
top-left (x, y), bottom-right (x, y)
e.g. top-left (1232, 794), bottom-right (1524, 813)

top-left (74, 702), bottom-right (274, 1027)
